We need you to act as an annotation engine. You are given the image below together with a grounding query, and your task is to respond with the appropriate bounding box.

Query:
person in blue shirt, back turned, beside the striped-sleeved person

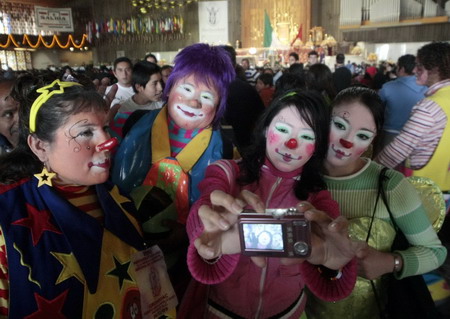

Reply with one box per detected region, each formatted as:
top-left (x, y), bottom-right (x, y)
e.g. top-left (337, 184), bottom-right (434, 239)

top-left (378, 54), bottom-right (427, 148)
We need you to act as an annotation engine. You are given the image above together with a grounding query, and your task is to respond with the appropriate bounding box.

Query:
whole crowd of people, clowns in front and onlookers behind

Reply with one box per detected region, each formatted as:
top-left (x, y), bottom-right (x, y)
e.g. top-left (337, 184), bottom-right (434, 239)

top-left (0, 42), bottom-right (450, 318)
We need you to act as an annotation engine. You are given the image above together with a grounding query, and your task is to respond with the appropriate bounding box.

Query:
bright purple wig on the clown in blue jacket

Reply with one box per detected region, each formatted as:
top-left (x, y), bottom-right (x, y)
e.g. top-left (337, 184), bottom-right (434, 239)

top-left (164, 43), bottom-right (236, 129)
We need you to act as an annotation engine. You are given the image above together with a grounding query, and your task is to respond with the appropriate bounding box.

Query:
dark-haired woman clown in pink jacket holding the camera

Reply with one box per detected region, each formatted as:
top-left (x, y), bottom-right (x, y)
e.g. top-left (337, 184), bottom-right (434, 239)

top-left (180, 91), bottom-right (360, 318)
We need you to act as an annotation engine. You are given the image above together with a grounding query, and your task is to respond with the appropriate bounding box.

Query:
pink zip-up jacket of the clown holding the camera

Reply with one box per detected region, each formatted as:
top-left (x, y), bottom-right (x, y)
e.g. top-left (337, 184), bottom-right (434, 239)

top-left (184, 160), bottom-right (357, 318)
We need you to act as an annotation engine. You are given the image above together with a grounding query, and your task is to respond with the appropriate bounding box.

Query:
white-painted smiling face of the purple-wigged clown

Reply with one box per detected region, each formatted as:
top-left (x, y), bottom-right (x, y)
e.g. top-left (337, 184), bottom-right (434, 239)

top-left (168, 75), bottom-right (219, 130)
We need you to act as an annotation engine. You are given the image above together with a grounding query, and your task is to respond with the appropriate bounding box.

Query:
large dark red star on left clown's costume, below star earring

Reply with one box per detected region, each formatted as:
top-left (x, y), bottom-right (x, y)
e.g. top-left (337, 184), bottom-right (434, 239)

top-left (12, 203), bottom-right (62, 246)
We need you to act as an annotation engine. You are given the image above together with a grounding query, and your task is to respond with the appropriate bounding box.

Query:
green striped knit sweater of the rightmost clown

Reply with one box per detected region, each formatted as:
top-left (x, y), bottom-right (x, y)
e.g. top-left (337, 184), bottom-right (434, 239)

top-left (325, 159), bottom-right (447, 278)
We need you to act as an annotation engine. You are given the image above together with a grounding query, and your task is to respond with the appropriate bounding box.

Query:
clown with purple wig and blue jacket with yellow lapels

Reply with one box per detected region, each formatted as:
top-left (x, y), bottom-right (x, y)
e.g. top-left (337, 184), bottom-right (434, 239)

top-left (112, 44), bottom-right (235, 267)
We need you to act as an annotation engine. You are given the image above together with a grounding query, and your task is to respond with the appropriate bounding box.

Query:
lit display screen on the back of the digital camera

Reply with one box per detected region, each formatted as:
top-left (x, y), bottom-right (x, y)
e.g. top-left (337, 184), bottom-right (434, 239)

top-left (242, 224), bottom-right (284, 250)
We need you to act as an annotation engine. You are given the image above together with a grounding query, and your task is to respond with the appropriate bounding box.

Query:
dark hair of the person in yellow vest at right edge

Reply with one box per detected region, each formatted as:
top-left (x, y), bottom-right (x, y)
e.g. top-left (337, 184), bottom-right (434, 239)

top-left (417, 42), bottom-right (450, 80)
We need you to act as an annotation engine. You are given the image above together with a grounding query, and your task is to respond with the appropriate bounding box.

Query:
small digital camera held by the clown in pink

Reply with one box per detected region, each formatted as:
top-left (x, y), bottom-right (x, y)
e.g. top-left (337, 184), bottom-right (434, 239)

top-left (239, 207), bottom-right (311, 258)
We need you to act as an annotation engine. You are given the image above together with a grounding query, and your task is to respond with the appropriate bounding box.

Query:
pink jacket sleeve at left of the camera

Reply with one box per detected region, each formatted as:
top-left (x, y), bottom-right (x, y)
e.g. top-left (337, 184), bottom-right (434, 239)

top-left (186, 160), bottom-right (240, 284)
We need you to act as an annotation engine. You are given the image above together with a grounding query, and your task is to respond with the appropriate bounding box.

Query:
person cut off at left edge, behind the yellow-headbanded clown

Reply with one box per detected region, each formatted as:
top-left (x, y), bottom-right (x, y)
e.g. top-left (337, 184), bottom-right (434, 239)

top-left (0, 79), bottom-right (19, 156)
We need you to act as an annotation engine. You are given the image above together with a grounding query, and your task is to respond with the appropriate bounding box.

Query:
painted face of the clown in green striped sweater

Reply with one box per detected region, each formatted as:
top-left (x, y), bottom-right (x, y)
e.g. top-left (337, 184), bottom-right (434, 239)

top-left (327, 102), bottom-right (376, 167)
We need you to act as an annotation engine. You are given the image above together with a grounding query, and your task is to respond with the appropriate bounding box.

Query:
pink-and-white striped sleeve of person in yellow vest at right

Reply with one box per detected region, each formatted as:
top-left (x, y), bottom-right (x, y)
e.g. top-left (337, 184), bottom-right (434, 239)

top-left (376, 99), bottom-right (446, 169)
